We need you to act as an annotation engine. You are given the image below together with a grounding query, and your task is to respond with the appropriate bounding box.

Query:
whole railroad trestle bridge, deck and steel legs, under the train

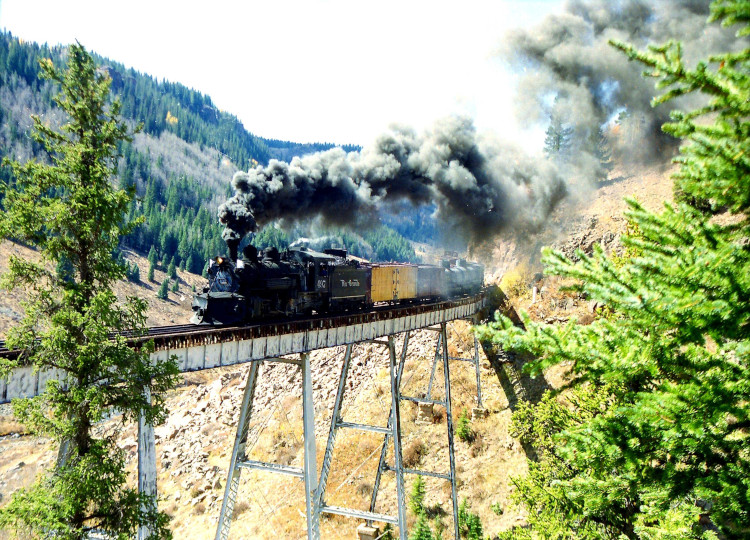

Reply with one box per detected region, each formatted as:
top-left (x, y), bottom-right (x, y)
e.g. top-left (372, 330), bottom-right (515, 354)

top-left (0, 294), bottom-right (487, 540)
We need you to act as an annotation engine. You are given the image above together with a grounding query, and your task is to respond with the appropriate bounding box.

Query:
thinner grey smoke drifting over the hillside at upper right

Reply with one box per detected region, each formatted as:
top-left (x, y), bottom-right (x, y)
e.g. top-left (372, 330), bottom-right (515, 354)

top-left (501, 0), bottom-right (747, 161)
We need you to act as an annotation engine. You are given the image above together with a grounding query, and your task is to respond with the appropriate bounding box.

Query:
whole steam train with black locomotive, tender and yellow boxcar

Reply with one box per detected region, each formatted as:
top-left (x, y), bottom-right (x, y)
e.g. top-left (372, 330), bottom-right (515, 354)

top-left (191, 245), bottom-right (484, 325)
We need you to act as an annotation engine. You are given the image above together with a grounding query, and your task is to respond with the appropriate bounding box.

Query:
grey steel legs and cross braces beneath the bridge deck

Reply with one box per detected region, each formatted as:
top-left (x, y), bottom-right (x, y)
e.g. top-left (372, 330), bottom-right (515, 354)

top-left (216, 322), bottom-right (488, 540)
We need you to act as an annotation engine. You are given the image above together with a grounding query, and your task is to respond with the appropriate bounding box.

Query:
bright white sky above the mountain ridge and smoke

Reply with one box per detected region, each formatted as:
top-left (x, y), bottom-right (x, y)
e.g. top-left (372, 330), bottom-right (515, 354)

top-left (0, 0), bottom-right (562, 145)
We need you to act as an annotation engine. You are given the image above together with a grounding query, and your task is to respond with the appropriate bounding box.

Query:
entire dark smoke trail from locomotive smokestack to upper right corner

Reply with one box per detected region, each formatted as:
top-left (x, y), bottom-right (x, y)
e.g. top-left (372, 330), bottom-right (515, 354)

top-left (219, 0), bottom-right (747, 253)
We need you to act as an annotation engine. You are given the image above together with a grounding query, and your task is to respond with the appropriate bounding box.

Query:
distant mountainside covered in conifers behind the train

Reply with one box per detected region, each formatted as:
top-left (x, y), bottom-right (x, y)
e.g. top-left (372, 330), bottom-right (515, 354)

top-left (0, 33), bottom-right (416, 274)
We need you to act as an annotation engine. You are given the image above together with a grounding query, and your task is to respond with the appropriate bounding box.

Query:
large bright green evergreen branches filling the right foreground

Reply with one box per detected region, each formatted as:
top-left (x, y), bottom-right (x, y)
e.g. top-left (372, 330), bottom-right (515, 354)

top-left (479, 0), bottom-right (750, 538)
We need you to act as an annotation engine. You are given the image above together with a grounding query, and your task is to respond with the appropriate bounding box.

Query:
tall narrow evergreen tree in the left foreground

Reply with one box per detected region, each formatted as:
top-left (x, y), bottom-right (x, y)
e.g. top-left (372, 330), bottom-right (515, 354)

top-left (0, 44), bottom-right (177, 539)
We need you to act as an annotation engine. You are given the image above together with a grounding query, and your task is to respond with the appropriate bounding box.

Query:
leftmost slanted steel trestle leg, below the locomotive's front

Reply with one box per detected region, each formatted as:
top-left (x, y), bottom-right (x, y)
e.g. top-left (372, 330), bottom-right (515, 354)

top-left (216, 361), bottom-right (261, 540)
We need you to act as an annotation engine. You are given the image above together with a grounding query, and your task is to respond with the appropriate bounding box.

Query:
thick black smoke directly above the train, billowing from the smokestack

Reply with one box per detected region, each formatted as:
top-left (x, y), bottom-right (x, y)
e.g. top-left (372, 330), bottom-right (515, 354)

top-left (219, 117), bottom-right (565, 250)
